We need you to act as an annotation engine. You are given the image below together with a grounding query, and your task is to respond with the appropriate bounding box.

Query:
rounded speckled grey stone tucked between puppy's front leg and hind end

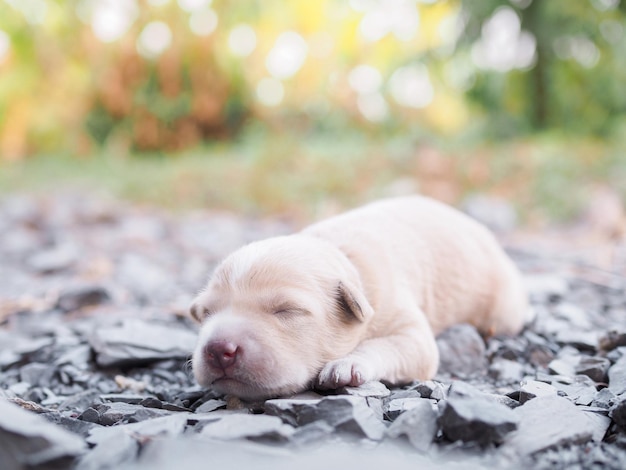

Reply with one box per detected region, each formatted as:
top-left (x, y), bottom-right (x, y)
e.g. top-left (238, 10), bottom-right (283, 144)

top-left (437, 324), bottom-right (487, 378)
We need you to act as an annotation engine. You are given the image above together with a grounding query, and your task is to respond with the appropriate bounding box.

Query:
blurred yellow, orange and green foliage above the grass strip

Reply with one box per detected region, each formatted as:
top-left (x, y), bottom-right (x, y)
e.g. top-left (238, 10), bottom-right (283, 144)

top-left (0, 0), bottom-right (626, 159)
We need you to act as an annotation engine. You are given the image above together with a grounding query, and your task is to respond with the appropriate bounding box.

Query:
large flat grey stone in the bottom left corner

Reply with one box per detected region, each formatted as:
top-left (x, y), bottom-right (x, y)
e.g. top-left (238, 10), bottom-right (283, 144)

top-left (0, 399), bottom-right (85, 469)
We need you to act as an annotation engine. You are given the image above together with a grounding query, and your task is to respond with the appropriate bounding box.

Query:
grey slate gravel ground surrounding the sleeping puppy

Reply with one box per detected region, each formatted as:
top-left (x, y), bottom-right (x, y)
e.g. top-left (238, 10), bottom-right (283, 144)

top-left (0, 195), bottom-right (626, 470)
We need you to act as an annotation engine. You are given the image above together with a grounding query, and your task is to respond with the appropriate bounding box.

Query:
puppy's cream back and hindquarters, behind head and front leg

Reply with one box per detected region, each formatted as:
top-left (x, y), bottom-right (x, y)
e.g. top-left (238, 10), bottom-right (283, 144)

top-left (303, 196), bottom-right (528, 334)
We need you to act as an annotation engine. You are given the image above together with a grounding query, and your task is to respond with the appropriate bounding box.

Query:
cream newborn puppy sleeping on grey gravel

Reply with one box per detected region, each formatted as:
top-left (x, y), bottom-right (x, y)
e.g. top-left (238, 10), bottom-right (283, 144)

top-left (191, 196), bottom-right (530, 399)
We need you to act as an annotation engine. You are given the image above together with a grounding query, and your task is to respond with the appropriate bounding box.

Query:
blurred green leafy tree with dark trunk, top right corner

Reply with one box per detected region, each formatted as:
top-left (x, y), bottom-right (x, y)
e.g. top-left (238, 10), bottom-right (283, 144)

top-left (458, 0), bottom-right (626, 135)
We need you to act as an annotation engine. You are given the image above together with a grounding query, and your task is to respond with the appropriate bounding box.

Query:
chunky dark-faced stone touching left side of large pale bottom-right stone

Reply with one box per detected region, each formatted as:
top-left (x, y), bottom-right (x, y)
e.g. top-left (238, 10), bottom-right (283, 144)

top-left (439, 396), bottom-right (519, 446)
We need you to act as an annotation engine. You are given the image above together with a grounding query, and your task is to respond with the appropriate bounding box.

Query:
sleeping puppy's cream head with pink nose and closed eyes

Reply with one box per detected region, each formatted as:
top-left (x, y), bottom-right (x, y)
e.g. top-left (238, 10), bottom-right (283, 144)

top-left (185, 235), bottom-right (373, 399)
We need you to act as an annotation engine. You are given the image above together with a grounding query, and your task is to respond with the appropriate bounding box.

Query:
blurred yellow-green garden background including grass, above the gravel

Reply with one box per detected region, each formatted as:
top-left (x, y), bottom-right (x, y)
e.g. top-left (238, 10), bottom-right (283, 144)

top-left (0, 0), bottom-right (626, 228)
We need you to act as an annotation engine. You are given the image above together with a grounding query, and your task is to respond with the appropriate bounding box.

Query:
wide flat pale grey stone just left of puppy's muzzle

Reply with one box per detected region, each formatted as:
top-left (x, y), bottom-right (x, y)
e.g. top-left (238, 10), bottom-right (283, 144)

top-left (89, 318), bottom-right (197, 367)
